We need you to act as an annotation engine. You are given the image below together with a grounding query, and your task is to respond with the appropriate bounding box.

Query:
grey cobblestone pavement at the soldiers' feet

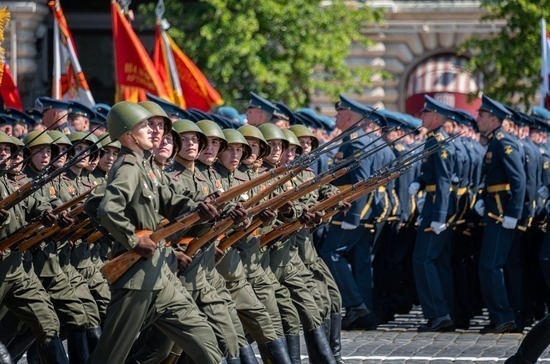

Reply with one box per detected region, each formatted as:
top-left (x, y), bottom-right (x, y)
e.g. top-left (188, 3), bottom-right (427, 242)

top-left (16, 307), bottom-right (550, 364)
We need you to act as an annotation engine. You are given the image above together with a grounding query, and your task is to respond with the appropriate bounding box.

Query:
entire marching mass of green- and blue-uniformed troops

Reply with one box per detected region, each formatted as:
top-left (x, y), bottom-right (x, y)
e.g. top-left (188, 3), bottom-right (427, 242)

top-left (0, 89), bottom-right (550, 364)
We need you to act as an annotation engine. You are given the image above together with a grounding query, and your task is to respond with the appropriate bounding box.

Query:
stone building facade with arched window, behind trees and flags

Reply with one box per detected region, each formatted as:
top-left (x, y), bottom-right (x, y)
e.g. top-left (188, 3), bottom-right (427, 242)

top-left (0, 0), bottom-right (503, 115)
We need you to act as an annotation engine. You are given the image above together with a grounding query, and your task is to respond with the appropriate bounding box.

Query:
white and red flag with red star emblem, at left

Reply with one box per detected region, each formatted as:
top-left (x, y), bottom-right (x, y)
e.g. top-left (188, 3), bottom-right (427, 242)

top-left (48, 0), bottom-right (95, 107)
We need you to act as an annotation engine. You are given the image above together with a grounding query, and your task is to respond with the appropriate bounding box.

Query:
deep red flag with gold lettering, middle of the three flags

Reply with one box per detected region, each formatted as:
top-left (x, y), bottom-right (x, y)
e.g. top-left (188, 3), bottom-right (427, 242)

top-left (111, 1), bottom-right (170, 101)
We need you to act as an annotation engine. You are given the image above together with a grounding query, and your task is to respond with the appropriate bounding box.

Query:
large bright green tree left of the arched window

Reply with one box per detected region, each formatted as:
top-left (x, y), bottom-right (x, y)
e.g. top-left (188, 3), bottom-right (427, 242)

top-left (140, 0), bottom-right (383, 107)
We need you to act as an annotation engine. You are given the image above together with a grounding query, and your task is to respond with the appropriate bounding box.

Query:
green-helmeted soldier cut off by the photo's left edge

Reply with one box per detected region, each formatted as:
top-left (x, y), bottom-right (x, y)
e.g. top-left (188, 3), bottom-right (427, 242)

top-left (0, 133), bottom-right (68, 363)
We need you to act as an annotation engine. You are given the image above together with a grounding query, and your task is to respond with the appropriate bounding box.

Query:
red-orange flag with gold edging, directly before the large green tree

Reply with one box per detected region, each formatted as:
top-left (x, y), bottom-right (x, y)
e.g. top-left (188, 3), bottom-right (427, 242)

top-left (154, 30), bottom-right (223, 111)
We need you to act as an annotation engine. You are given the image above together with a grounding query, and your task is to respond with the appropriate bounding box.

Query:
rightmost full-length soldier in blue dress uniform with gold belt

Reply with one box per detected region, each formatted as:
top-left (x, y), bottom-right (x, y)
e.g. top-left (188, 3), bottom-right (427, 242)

top-left (476, 95), bottom-right (526, 333)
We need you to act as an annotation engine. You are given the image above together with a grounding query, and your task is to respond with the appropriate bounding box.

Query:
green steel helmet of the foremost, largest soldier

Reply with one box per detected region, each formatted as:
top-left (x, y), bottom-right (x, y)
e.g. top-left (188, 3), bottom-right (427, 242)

top-left (107, 101), bottom-right (153, 140)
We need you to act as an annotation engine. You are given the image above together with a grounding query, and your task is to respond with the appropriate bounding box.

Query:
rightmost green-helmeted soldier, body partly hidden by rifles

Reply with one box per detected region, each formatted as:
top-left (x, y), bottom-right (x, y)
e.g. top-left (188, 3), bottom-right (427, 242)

top-left (290, 125), bottom-right (347, 363)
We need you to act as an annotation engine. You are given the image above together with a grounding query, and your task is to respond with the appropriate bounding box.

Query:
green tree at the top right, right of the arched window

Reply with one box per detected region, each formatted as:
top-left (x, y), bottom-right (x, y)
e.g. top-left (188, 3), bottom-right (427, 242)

top-left (461, 0), bottom-right (550, 105)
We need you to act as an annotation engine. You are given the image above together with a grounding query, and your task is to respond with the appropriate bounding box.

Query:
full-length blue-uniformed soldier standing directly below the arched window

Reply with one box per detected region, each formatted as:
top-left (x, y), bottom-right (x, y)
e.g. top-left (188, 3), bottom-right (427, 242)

top-left (409, 96), bottom-right (455, 332)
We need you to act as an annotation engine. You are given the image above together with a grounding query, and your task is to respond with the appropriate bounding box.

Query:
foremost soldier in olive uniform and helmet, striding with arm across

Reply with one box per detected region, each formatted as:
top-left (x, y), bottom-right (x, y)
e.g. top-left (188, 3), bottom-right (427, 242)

top-left (90, 101), bottom-right (222, 364)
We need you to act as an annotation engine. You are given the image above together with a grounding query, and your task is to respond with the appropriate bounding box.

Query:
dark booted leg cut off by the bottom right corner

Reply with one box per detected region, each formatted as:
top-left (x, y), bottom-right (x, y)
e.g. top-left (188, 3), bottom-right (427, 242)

top-left (506, 315), bottom-right (550, 364)
